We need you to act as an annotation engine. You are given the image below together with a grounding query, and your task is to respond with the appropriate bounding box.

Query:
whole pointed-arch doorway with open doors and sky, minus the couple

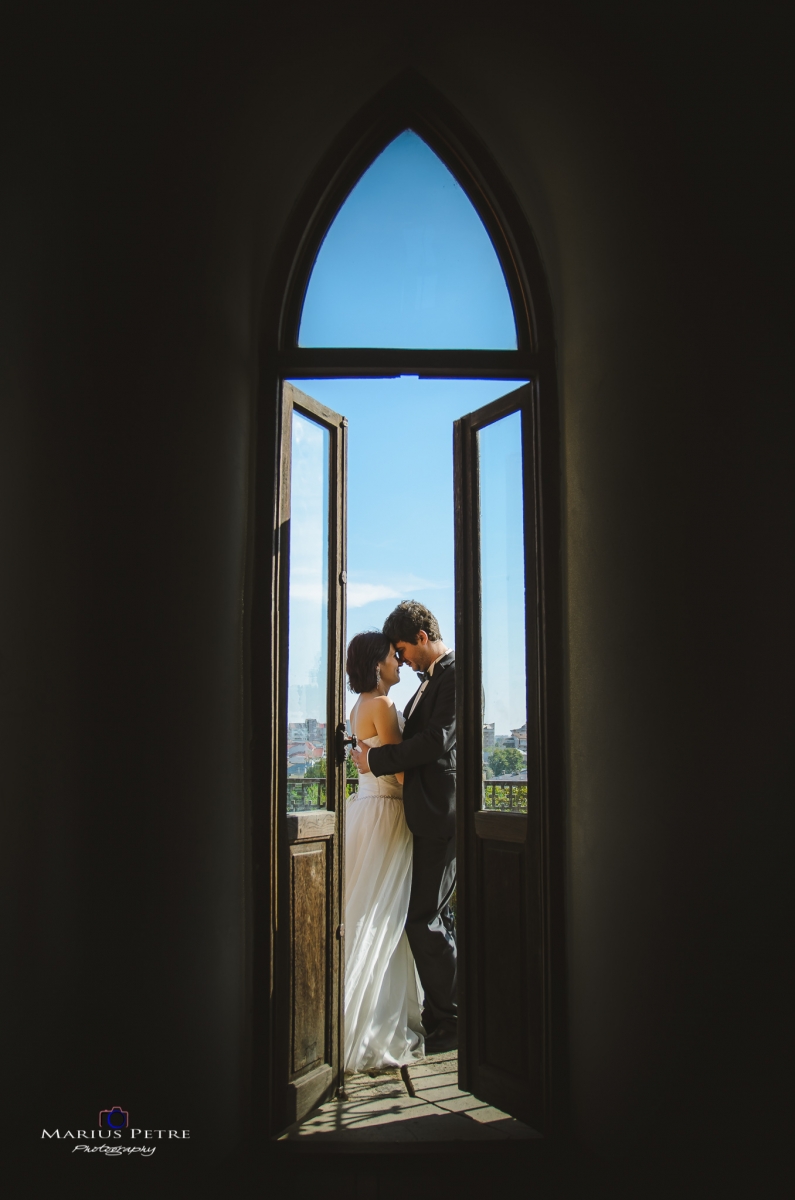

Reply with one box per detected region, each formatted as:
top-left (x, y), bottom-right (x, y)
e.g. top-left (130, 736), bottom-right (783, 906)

top-left (253, 80), bottom-right (560, 1152)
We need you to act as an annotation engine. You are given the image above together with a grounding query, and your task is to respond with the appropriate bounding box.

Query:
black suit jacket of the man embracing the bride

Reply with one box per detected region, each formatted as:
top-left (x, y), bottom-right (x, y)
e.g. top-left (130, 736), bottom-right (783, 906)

top-left (367, 650), bottom-right (455, 838)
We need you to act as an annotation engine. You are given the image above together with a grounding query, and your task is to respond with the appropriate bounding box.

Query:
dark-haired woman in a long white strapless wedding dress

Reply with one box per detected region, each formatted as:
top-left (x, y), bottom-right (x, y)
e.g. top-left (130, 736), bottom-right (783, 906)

top-left (345, 632), bottom-right (424, 1072)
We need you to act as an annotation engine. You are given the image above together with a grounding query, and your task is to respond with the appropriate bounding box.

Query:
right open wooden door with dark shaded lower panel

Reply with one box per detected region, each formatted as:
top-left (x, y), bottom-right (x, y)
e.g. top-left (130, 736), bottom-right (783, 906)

top-left (454, 384), bottom-right (548, 1132)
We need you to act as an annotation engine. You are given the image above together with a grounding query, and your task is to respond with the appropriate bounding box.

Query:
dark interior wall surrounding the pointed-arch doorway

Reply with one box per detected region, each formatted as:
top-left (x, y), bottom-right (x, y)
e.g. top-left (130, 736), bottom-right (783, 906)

top-left (0, 2), bottom-right (791, 1180)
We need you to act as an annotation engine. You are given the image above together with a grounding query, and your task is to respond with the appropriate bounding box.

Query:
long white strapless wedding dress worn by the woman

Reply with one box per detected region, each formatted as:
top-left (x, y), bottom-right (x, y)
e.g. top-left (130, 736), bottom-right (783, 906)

top-left (345, 714), bottom-right (425, 1072)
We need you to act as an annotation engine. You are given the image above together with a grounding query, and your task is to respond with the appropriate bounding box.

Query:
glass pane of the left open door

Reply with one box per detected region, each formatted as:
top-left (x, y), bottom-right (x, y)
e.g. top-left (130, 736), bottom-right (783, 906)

top-left (287, 409), bottom-right (333, 812)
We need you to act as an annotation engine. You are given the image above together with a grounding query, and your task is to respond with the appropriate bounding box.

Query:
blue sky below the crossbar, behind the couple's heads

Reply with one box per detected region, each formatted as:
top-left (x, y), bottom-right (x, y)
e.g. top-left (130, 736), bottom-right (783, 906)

top-left (291, 377), bottom-right (525, 733)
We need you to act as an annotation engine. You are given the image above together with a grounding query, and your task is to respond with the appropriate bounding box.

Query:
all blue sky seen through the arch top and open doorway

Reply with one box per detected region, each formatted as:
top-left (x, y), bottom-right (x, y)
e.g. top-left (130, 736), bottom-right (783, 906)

top-left (289, 133), bottom-right (525, 733)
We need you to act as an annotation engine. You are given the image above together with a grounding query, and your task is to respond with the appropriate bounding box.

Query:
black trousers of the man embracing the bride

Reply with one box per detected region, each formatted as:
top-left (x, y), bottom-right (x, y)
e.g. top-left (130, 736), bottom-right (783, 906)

top-left (406, 835), bottom-right (458, 1027)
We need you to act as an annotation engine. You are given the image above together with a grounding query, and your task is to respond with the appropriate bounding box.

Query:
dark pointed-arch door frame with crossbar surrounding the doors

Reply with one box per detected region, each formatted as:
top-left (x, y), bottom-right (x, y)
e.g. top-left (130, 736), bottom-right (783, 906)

top-left (249, 72), bottom-right (569, 1138)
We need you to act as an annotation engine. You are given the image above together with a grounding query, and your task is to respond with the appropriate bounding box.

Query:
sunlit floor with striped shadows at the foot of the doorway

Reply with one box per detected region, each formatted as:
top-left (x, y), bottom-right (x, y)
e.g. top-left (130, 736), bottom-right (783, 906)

top-left (280, 1050), bottom-right (537, 1142)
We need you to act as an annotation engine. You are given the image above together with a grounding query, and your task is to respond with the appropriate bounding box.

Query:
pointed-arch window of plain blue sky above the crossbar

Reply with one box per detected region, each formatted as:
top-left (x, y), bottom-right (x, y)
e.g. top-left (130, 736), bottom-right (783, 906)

top-left (298, 130), bottom-right (516, 350)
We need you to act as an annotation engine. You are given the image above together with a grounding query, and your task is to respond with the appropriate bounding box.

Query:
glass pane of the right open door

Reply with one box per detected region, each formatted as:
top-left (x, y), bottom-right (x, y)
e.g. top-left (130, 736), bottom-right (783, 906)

top-left (478, 413), bottom-right (527, 812)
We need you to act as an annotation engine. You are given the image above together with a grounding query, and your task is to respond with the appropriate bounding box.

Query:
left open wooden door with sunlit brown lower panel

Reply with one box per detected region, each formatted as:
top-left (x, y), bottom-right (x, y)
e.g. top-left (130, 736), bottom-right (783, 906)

top-left (273, 383), bottom-right (347, 1129)
